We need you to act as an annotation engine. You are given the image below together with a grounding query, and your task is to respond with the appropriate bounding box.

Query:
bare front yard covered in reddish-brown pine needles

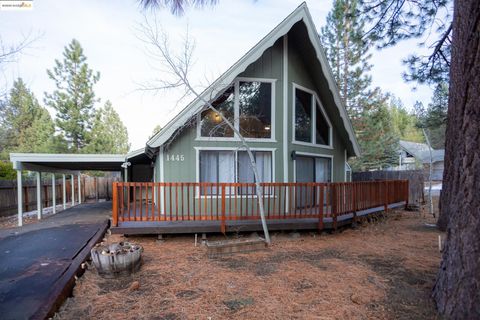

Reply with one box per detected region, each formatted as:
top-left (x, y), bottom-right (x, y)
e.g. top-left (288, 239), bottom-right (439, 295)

top-left (55, 211), bottom-right (440, 319)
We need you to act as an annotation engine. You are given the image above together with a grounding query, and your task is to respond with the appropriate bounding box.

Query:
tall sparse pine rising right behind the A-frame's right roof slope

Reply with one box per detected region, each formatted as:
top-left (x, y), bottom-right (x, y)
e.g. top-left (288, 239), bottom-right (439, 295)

top-left (321, 0), bottom-right (372, 122)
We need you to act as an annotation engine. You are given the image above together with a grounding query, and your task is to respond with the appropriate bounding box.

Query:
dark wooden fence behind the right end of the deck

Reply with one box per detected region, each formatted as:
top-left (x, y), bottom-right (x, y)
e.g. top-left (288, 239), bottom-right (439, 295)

top-left (352, 170), bottom-right (425, 207)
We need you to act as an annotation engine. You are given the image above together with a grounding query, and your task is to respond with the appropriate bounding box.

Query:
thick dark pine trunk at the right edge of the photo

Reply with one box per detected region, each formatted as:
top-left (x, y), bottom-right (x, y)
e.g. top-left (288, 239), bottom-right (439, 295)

top-left (433, 0), bottom-right (480, 319)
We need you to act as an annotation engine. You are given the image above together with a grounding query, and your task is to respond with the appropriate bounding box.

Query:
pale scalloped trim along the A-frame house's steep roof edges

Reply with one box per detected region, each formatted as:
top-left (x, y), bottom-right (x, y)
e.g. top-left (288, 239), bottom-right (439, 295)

top-left (147, 2), bottom-right (360, 156)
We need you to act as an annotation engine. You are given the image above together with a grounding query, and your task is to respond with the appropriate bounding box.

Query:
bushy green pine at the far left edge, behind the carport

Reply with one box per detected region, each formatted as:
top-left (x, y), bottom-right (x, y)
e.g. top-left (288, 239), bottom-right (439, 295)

top-left (1, 79), bottom-right (55, 158)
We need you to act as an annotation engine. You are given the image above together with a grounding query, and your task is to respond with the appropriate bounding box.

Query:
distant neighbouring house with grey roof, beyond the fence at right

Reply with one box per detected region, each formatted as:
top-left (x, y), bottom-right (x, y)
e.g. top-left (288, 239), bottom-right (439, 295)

top-left (397, 140), bottom-right (445, 181)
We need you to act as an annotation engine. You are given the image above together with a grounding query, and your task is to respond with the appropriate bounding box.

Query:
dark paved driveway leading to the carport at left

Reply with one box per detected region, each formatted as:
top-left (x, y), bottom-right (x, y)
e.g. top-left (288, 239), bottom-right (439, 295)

top-left (0, 202), bottom-right (111, 319)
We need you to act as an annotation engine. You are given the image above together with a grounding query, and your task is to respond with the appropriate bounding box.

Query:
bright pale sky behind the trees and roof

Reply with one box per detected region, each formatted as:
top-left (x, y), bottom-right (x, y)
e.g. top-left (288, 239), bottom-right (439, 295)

top-left (0, 0), bottom-right (432, 150)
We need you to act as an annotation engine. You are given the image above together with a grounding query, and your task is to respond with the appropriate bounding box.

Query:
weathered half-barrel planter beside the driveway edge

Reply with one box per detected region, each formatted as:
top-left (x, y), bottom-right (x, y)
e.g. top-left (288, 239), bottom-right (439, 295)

top-left (91, 242), bottom-right (143, 278)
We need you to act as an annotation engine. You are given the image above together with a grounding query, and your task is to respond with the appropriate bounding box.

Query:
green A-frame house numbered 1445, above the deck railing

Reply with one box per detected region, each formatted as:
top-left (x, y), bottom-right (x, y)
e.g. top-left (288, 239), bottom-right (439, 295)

top-left (141, 5), bottom-right (359, 188)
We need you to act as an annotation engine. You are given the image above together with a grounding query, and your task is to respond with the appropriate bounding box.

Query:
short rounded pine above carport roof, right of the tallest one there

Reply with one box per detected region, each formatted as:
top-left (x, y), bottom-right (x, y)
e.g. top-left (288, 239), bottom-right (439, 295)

top-left (83, 101), bottom-right (130, 154)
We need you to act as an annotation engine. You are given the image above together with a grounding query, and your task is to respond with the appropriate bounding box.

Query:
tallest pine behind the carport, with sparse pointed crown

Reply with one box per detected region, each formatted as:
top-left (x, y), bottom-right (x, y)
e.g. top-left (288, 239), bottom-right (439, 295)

top-left (45, 39), bottom-right (100, 152)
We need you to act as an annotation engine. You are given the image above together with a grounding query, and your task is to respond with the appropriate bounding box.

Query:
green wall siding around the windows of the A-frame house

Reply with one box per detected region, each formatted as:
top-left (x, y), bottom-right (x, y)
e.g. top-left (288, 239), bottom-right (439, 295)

top-left (155, 22), bottom-right (346, 182)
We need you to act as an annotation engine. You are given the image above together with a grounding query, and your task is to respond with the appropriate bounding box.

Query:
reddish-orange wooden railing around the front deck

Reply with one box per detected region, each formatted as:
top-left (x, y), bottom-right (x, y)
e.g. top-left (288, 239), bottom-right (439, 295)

top-left (112, 180), bottom-right (408, 232)
